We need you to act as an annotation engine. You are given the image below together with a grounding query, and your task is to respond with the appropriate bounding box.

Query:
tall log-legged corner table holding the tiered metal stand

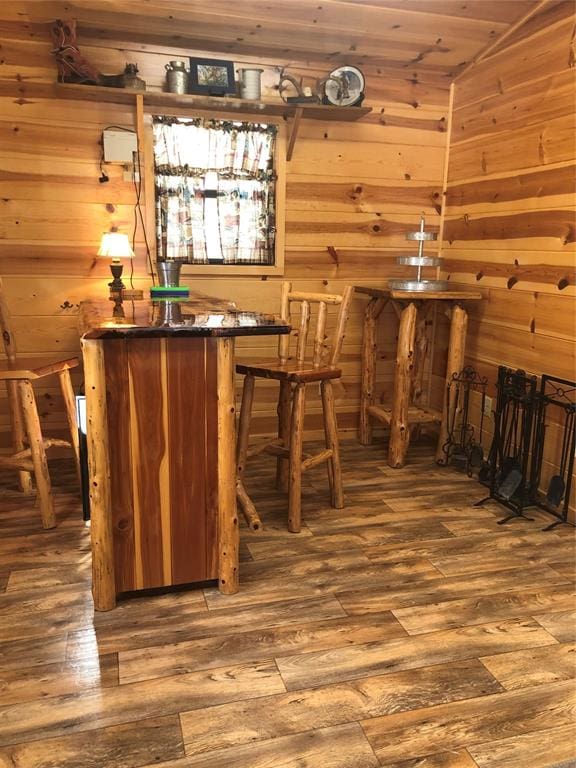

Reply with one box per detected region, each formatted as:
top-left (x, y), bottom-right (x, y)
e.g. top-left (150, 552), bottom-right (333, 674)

top-left (355, 286), bottom-right (482, 467)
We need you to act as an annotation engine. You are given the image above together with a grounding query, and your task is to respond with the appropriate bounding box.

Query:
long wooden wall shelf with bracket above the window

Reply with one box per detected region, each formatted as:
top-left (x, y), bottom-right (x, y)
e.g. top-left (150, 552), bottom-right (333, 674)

top-left (0, 81), bottom-right (372, 160)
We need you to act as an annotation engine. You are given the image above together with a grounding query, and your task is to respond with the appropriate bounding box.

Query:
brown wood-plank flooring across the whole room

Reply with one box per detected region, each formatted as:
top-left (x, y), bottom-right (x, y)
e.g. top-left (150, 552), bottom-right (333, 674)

top-left (0, 442), bottom-right (576, 768)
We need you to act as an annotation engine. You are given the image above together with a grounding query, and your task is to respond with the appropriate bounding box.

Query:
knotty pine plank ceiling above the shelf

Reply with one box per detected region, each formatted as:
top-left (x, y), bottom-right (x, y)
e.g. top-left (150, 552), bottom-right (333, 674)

top-left (0, 0), bottom-right (548, 77)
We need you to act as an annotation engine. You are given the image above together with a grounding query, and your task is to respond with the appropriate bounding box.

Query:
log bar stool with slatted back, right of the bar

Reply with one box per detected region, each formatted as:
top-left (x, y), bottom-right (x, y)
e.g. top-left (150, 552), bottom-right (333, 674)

top-left (236, 282), bottom-right (353, 533)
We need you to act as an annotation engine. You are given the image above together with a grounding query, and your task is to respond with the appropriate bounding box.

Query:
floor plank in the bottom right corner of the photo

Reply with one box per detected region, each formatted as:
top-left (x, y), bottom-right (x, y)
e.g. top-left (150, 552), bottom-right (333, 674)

top-left (470, 726), bottom-right (576, 768)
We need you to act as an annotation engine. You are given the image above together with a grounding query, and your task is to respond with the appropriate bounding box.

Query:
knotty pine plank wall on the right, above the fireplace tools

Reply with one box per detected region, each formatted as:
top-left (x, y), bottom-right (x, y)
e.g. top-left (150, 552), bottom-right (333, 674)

top-left (443, 3), bottom-right (576, 510)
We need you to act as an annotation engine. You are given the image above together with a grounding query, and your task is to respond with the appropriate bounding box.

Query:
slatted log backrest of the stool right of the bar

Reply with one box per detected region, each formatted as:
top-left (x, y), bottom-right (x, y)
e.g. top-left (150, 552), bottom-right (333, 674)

top-left (278, 281), bottom-right (354, 368)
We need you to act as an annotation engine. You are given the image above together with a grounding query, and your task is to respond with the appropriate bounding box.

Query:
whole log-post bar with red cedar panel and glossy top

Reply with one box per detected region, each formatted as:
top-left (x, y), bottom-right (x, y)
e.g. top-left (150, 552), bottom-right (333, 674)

top-left (80, 296), bottom-right (290, 611)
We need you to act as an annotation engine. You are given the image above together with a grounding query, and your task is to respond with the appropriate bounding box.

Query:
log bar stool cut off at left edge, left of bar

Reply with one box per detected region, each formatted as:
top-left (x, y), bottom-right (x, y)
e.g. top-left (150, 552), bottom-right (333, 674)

top-left (0, 280), bottom-right (80, 528)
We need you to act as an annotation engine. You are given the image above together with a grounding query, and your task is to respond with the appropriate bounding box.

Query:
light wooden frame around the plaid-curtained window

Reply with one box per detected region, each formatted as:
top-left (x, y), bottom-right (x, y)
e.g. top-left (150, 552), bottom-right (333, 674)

top-left (141, 108), bottom-right (286, 277)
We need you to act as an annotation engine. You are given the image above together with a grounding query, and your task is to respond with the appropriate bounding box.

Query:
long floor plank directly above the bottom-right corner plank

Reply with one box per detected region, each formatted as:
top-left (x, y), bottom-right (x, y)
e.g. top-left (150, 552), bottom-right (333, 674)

top-left (362, 681), bottom-right (576, 768)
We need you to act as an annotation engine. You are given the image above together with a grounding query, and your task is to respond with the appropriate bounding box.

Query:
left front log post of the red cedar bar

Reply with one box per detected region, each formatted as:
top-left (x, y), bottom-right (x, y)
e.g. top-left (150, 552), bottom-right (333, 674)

top-left (82, 339), bottom-right (116, 611)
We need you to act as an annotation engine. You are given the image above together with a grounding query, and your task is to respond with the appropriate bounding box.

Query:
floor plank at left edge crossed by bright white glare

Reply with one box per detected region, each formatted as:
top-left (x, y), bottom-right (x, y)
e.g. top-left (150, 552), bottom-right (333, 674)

top-left (0, 653), bottom-right (118, 707)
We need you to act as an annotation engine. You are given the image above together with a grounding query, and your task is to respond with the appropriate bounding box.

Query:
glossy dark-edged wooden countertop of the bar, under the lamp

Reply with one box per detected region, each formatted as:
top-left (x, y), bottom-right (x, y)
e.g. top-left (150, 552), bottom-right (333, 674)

top-left (79, 294), bottom-right (290, 339)
